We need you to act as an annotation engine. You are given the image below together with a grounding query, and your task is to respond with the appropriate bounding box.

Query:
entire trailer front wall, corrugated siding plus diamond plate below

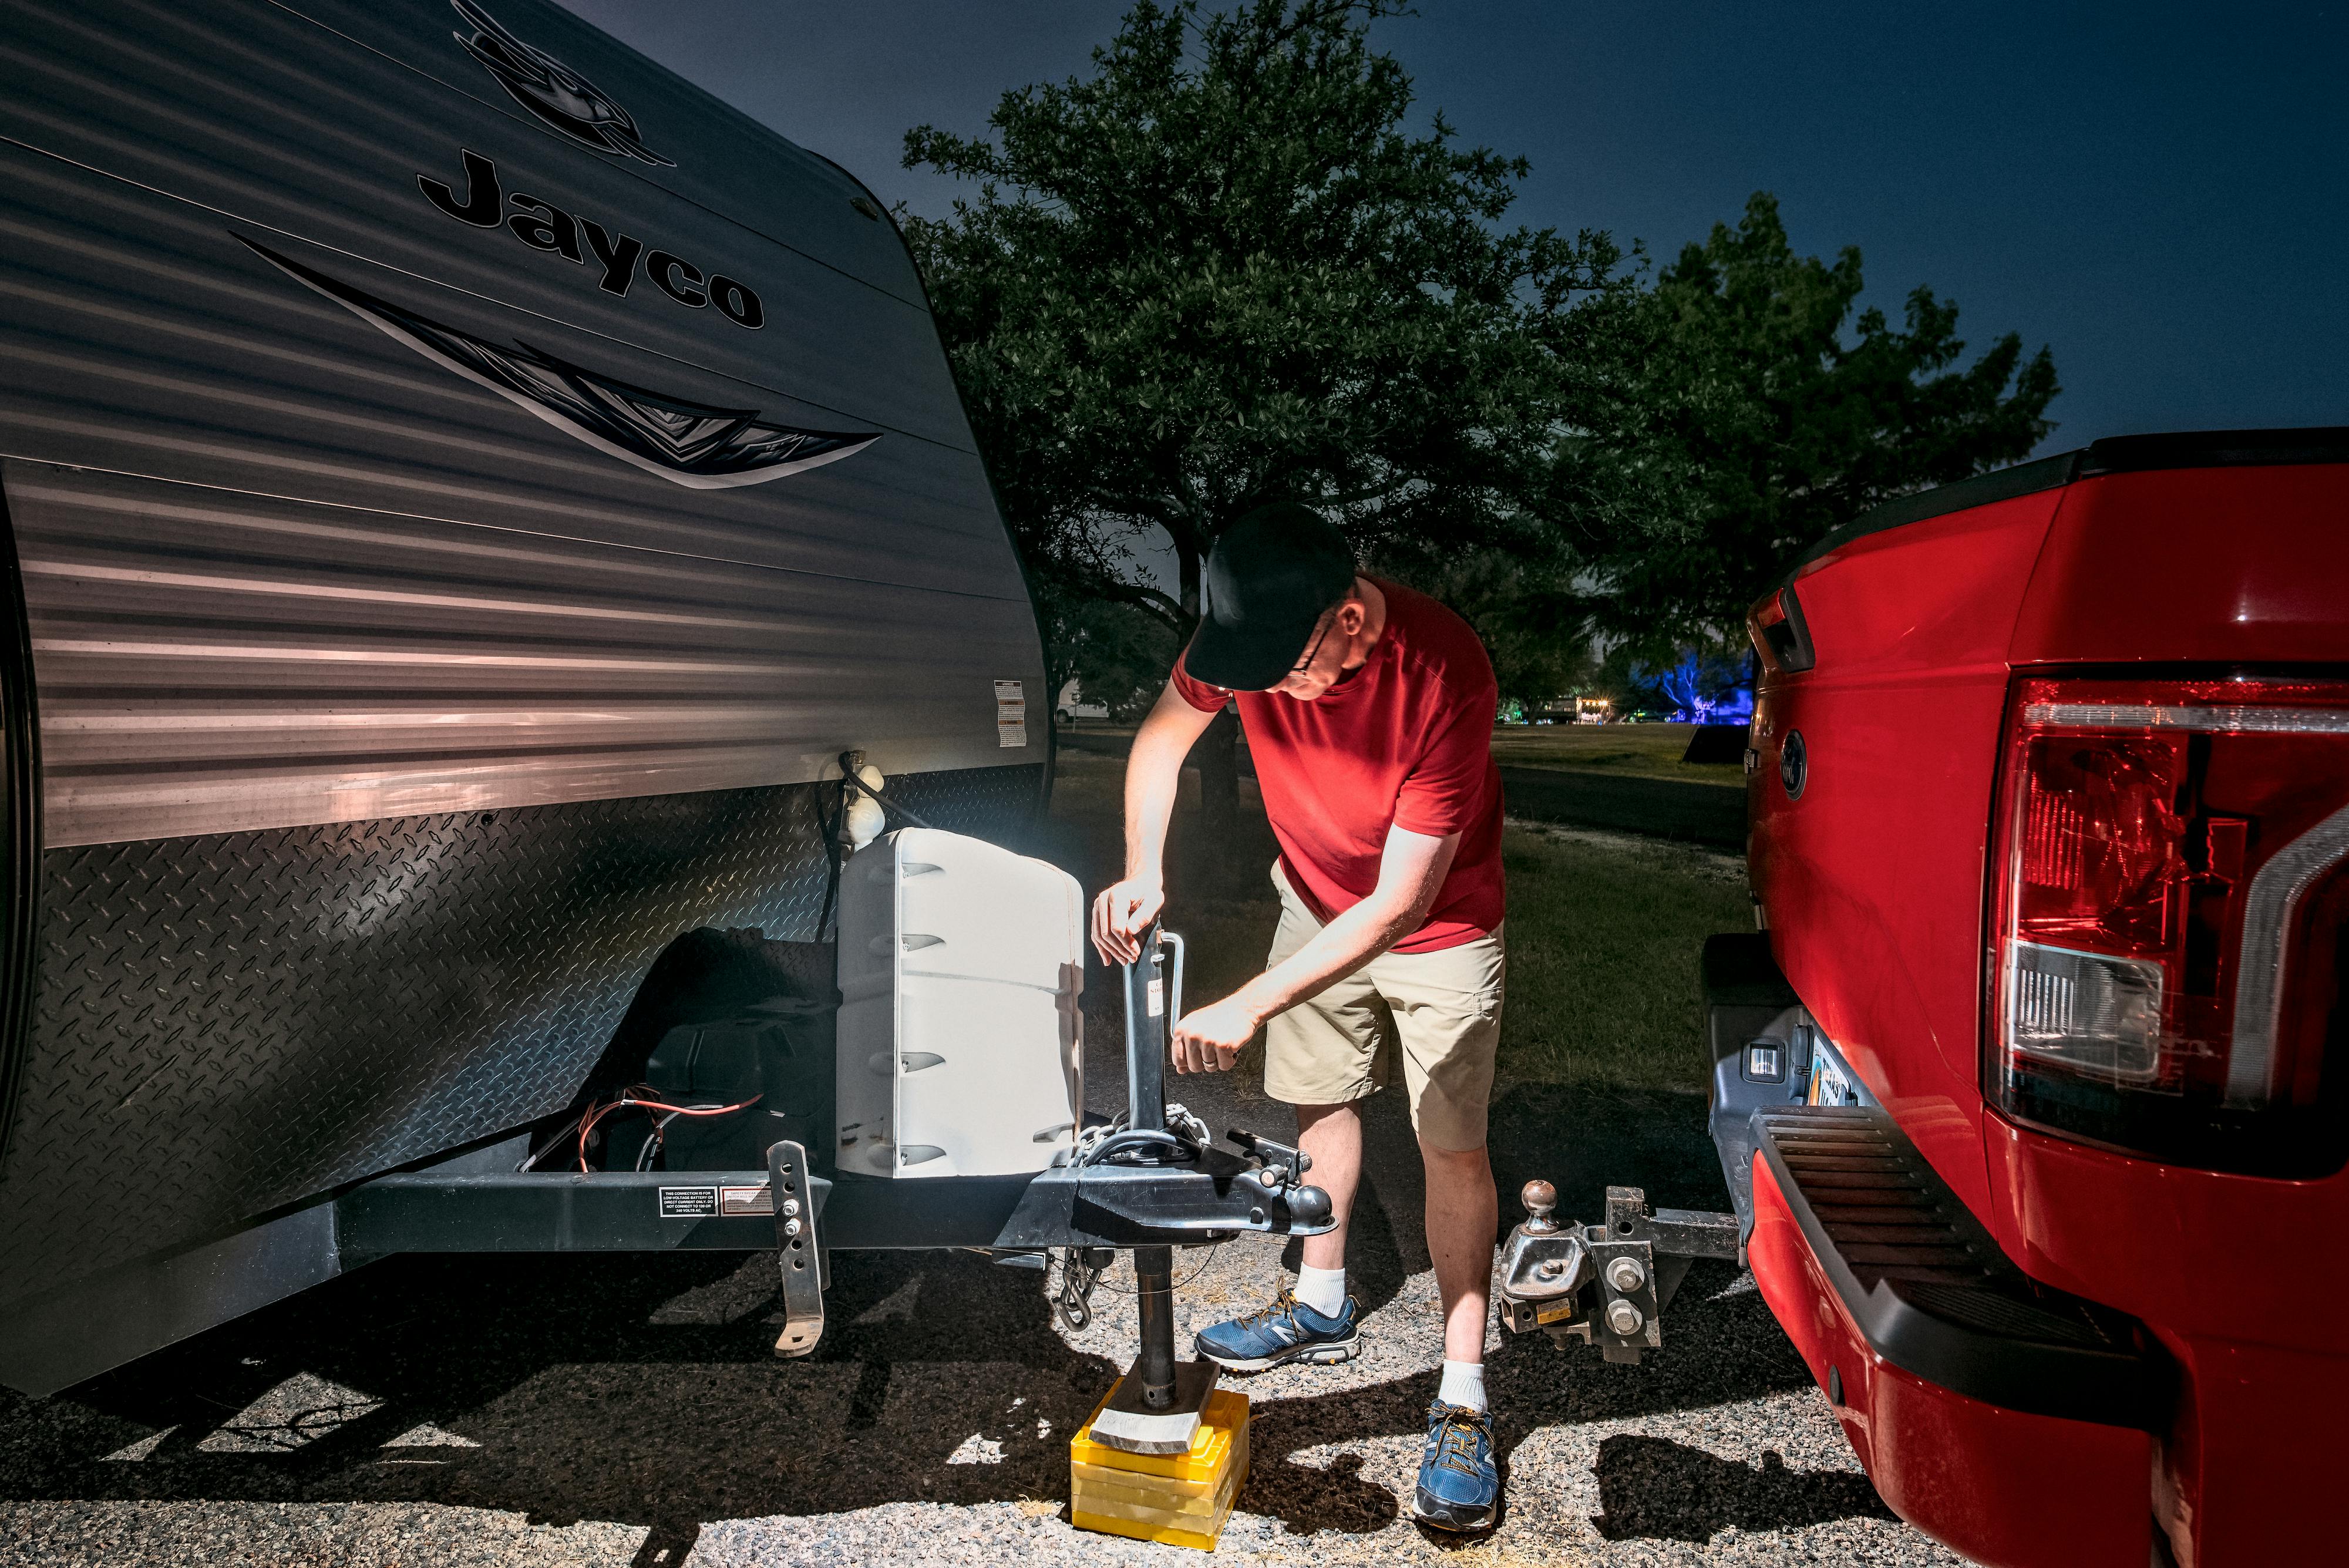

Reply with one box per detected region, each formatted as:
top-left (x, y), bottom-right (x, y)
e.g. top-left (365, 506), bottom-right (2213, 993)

top-left (0, 0), bottom-right (1050, 1364)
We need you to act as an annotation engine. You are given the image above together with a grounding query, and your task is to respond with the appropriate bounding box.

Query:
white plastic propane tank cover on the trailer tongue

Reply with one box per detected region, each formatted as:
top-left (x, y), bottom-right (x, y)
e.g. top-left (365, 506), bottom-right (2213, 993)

top-left (836, 829), bottom-right (1085, 1176)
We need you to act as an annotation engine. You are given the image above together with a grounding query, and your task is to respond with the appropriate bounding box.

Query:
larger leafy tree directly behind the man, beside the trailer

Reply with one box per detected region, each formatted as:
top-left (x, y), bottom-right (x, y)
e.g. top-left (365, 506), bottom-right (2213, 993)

top-left (904, 0), bottom-right (1628, 831)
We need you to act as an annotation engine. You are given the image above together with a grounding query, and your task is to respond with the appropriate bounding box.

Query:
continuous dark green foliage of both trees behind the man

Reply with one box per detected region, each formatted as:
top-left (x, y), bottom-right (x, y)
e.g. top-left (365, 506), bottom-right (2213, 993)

top-left (904, 0), bottom-right (2058, 699)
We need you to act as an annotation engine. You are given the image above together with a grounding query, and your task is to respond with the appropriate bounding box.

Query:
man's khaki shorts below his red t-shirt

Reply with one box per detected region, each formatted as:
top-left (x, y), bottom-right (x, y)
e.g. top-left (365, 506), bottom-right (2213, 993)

top-left (1264, 862), bottom-right (1506, 1153)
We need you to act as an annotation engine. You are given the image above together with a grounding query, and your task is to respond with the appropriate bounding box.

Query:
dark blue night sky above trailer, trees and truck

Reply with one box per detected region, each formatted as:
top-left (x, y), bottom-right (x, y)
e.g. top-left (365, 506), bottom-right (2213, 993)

top-left (566, 0), bottom-right (2349, 450)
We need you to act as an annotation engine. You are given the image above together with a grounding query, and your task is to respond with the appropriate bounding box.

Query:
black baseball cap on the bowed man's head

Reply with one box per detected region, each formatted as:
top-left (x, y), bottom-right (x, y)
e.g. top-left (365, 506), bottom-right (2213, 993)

top-left (1182, 500), bottom-right (1353, 692)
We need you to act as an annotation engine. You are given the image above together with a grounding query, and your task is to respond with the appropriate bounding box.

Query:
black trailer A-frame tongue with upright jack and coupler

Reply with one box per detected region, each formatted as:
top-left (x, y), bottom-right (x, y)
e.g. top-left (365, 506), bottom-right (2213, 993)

top-left (334, 906), bottom-right (1334, 1418)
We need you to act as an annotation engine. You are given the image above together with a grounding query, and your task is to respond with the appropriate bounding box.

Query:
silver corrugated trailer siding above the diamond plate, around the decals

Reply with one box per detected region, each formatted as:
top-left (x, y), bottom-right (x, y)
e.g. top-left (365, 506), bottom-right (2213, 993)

top-left (0, 2), bottom-right (1045, 847)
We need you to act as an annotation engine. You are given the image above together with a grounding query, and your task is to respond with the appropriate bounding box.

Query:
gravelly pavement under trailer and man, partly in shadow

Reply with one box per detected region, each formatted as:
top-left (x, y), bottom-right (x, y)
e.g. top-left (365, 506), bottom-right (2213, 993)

top-left (0, 910), bottom-right (1961, 1568)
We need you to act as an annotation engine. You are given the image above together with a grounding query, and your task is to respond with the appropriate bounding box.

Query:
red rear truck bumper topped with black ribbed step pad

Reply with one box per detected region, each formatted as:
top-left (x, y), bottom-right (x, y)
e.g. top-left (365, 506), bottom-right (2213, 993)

top-left (1745, 1108), bottom-right (2173, 1568)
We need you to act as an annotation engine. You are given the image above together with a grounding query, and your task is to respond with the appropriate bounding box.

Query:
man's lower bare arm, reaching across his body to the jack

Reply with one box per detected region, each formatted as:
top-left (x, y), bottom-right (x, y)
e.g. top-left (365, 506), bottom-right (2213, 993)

top-left (1174, 826), bottom-right (1461, 1073)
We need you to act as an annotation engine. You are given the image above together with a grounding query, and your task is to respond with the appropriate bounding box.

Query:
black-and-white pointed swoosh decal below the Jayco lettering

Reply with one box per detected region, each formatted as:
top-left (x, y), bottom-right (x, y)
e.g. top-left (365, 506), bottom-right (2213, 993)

top-left (237, 235), bottom-right (881, 490)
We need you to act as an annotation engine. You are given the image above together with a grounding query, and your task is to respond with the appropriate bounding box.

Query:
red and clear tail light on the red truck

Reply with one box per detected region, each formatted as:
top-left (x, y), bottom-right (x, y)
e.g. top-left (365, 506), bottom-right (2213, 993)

top-left (1985, 676), bottom-right (2349, 1176)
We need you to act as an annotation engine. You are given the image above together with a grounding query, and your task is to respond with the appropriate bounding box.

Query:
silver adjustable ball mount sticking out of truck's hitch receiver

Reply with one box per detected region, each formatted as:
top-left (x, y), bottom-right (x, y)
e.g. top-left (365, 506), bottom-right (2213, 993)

top-left (1496, 1180), bottom-right (1738, 1361)
